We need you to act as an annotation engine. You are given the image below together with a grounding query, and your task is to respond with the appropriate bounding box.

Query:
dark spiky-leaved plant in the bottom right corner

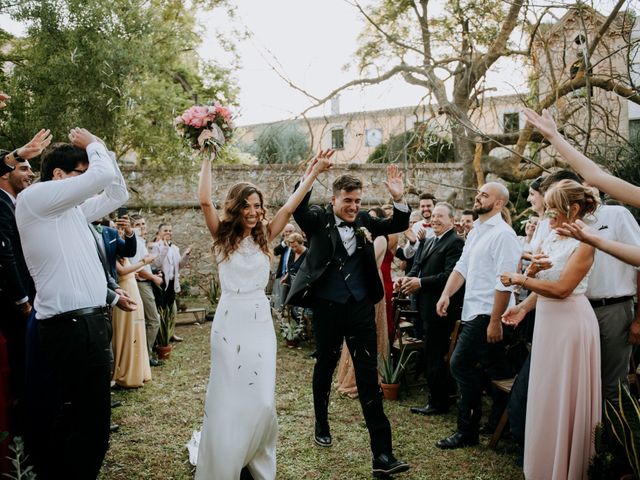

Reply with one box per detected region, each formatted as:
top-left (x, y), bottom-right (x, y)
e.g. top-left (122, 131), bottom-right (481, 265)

top-left (605, 384), bottom-right (640, 480)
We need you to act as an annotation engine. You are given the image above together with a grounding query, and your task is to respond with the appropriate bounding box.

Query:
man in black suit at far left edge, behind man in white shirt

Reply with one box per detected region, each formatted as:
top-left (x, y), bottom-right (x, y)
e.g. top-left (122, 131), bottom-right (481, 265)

top-left (0, 152), bottom-right (36, 434)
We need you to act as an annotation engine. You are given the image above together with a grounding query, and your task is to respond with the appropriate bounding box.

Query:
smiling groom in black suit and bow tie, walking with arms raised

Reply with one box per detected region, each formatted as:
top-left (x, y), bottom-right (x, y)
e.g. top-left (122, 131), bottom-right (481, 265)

top-left (286, 165), bottom-right (409, 476)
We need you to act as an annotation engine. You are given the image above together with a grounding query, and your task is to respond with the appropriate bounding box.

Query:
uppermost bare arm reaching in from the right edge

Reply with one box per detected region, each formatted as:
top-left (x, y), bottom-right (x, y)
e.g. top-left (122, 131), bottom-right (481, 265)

top-left (524, 108), bottom-right (640, 207)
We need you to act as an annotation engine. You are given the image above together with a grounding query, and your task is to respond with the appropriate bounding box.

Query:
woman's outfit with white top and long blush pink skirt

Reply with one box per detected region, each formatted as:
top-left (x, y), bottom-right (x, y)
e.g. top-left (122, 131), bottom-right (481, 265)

top-left (524, 232), bottom-right (602, 480)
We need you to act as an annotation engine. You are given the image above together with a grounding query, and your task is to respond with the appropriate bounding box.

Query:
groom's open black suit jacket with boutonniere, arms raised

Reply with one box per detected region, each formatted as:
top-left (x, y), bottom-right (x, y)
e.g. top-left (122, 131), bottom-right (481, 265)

top-left (285, 192), bottom-right (410, 307)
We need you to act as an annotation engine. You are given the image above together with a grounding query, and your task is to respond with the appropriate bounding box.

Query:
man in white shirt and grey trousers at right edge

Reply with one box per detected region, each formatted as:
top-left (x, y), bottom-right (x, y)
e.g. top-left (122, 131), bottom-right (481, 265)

top-left (586, 205), bottom-right (640, 404)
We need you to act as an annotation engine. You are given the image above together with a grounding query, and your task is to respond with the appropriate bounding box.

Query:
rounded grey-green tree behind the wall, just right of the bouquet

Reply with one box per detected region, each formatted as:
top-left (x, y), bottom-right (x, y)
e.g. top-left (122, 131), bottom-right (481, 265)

top-left (249, 122), bottom-right (309, 163)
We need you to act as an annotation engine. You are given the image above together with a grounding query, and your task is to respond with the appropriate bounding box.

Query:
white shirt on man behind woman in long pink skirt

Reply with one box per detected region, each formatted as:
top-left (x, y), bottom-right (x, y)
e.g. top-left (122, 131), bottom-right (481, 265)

top-left (586, 205), bottom-right (640, 300)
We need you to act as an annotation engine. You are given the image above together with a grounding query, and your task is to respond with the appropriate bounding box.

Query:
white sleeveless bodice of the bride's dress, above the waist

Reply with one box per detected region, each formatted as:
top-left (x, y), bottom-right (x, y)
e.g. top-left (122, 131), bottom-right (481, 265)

top-left (218, 237), bottom-right (270, 295)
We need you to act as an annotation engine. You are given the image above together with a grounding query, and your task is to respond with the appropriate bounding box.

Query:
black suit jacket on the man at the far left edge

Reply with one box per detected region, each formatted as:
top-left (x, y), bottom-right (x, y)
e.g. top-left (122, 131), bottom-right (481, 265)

top-left (0, 190), bottom-right (34, 305)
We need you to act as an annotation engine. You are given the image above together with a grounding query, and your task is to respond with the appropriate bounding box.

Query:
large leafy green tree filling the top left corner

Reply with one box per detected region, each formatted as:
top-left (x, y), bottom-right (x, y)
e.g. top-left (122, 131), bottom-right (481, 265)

top-left (0, 0), bottom-right (237, 167)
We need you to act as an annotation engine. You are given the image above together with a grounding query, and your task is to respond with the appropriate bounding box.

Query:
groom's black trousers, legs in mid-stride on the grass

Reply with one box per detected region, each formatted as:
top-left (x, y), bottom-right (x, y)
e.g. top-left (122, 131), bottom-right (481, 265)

top-left (313, 299), bottom-right (392, 457)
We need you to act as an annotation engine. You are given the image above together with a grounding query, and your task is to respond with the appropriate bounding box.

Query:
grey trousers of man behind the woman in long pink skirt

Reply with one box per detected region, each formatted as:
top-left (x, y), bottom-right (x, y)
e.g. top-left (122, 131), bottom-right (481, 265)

top-left (593, 300), bottom-right (634, 404)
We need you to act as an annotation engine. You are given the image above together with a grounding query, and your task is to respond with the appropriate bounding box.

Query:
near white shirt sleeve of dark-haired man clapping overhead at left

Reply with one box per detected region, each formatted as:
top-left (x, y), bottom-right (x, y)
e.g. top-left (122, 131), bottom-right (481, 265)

top-left (24, 142), bottom-right (115, 217)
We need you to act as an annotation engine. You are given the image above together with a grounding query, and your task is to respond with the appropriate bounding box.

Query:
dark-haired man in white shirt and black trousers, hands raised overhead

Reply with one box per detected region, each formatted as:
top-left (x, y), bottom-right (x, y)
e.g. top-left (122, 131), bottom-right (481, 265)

top-left (16, 128), bottom-right (130, 479)
